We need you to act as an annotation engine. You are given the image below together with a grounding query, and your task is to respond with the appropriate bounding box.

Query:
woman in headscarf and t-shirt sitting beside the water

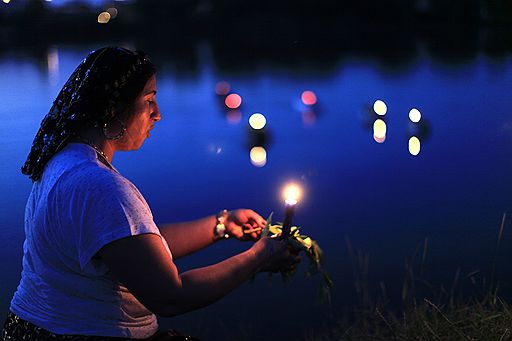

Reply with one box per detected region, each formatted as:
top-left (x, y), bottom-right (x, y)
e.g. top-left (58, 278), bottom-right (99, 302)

top-left (2, 47), bottom-right (299, 340)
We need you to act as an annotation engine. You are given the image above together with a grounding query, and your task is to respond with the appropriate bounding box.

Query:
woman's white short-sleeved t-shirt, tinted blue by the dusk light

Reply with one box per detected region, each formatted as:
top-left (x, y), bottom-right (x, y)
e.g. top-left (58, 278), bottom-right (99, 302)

top-left (11, 143), bottom-right (172, 339)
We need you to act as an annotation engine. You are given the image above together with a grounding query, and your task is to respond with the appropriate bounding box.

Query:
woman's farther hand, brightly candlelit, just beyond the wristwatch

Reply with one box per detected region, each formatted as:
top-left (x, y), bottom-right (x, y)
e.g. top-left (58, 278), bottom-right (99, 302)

top-left (224, 209), bottom-right (266, 241)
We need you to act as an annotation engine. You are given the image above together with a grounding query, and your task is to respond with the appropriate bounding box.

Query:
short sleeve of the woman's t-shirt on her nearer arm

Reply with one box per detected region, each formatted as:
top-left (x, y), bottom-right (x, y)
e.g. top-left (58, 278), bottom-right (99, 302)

top-left (73, 170), bottom-right (161, 271)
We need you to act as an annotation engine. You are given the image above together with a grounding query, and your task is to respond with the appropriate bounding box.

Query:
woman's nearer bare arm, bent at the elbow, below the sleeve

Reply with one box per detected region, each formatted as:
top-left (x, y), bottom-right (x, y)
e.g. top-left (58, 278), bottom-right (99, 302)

top-left (99, 234), bottom-right (299, 316)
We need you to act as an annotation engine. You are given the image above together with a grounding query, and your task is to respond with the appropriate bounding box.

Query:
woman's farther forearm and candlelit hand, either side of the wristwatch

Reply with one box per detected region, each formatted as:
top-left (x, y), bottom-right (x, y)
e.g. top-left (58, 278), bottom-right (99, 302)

top-left (159, 209), bottom-right (265, 259)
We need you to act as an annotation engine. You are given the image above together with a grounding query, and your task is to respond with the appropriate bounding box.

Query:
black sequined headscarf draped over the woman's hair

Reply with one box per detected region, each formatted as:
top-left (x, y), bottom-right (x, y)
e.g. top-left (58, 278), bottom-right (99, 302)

top-left (21, 47), bottom-right (156, 181)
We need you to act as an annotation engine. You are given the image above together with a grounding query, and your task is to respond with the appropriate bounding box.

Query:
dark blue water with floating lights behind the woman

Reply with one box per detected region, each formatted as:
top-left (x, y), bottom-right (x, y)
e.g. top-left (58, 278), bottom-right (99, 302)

top-left (0, 44), bottom-right (512, 340)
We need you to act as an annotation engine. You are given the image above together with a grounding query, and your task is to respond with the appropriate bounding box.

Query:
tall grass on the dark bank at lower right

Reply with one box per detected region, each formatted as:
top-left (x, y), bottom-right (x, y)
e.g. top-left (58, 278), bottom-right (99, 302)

top-left (307, 214), bottom-right (512, 341)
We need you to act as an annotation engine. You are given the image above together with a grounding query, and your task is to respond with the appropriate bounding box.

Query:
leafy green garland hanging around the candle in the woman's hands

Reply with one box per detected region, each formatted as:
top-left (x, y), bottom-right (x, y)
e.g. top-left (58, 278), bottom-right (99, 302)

top-left (261, 212), bottom-right (333, 299)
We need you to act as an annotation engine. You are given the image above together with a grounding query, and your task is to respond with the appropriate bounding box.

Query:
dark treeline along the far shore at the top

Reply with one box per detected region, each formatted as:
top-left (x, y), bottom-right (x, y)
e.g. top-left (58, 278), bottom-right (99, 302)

top-left (0, 0), bottom-right (512, 72)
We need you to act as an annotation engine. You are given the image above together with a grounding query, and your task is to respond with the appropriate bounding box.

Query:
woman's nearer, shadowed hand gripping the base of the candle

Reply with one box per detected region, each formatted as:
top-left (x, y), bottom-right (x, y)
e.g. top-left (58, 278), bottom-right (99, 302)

top-left (252, 237), bottom-right (301, 272)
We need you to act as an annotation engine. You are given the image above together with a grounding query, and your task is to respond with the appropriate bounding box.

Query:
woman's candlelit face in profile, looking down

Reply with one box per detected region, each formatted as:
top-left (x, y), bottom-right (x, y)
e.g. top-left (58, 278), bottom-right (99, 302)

top-left (116, 75), bottom-right (160, 150)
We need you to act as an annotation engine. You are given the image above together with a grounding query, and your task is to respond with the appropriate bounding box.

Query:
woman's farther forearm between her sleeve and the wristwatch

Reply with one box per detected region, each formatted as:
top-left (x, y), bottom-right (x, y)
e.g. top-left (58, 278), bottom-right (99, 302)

top-left (159, 215), bottom-right (217, 259)
